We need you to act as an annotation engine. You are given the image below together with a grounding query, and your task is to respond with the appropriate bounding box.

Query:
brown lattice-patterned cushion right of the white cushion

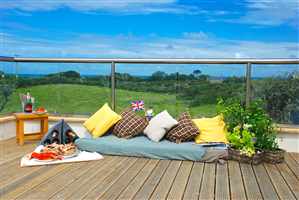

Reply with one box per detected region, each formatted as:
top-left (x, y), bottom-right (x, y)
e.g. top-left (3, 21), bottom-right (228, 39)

top-left (166, 112), bottom-right (199, 143)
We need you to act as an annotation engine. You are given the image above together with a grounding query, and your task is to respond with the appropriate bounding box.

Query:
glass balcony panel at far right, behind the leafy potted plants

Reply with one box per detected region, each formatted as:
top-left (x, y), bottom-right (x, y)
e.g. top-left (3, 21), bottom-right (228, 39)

top-left (252, 65), bottom-right (299, 124)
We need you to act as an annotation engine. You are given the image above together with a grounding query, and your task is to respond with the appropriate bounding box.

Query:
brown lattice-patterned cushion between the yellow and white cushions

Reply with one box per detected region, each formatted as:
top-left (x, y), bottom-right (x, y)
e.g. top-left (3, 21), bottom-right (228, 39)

top-left (112, 108), bottom-right (148, 138)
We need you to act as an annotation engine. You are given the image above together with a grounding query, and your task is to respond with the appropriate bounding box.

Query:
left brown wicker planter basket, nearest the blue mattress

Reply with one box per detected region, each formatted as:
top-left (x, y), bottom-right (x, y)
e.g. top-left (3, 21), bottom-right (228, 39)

top-left (228, 147), bottom-right (264, 165)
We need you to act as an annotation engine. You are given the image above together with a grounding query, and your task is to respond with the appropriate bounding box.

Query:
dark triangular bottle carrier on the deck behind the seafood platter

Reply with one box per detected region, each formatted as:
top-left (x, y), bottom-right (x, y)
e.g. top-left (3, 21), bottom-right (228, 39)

top-left (40, 119), bottom-right (79, 145)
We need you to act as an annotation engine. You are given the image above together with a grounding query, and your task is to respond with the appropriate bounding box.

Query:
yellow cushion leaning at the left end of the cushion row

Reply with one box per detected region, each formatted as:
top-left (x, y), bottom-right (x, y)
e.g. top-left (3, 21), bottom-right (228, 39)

top-left (83, 103), bottom-right (121, 138)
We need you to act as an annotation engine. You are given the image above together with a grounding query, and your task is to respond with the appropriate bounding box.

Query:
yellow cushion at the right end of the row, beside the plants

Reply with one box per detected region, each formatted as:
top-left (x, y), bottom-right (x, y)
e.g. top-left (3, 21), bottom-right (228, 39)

top-left (193, 115), bottom-right (228, 144)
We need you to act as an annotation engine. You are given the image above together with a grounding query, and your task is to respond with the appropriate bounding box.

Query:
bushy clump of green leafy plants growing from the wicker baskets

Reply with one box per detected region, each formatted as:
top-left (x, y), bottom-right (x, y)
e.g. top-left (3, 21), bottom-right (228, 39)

top-left (217, 99), bottom-right (278, 150)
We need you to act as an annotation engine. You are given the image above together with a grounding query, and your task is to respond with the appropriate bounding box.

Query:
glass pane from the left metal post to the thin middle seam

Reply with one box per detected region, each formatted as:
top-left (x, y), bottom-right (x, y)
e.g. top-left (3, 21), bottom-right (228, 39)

top-left (116, 64), bottom-right (178, 117)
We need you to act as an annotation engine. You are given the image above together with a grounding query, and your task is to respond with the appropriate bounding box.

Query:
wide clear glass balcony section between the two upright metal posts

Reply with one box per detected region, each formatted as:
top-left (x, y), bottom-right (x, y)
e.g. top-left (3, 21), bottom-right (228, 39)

top-left (116, 64), bottom-right (245, 117)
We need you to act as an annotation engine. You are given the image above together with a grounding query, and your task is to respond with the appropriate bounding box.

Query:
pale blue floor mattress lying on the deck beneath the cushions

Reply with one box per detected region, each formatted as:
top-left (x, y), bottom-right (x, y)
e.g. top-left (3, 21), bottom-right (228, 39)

top-left (75, 134), bottom-right (205, 161)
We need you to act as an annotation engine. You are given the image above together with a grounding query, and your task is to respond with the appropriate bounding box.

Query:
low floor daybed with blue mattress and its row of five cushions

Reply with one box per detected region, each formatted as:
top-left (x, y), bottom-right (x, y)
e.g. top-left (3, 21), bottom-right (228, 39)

top-left (76, 103), bottom-right (227, 162)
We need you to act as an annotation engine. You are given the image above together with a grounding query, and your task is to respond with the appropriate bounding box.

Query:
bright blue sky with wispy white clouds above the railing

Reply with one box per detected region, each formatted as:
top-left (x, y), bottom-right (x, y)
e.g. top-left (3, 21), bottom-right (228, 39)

top-left (0, 0), bottom-right (299, 75)
